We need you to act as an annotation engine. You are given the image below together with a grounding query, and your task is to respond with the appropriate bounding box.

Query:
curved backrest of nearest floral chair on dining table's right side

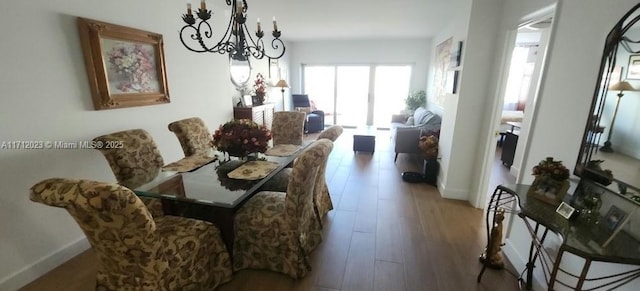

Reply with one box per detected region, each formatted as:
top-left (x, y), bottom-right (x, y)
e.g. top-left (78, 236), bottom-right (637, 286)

top-left (285, 139), bottom-right (333, 234)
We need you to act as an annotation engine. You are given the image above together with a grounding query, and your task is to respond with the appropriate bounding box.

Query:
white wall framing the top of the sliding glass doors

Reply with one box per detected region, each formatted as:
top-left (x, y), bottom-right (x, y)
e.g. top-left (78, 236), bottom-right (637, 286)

top-left (289, 39), bottom-right (432, 98)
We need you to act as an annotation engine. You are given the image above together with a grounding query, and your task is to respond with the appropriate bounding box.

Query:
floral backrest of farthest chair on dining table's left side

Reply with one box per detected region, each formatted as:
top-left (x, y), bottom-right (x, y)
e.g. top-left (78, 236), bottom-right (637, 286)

top-left (169, 117), bottom-right (213, 157)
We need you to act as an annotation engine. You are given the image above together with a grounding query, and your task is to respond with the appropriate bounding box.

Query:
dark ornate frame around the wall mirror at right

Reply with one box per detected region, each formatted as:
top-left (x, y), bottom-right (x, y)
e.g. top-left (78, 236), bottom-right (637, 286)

top-left (573, 4), bottom-right (640, 194)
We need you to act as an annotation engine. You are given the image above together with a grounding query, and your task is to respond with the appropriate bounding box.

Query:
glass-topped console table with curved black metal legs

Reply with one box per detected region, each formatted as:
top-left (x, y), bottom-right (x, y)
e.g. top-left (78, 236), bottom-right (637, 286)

top-left (477, 184), bottom-right (640, 290)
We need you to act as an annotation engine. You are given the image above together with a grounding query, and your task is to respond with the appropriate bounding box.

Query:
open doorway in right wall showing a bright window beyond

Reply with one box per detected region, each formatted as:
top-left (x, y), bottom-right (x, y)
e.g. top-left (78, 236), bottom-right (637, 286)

top-left (480, 13), bottom-right (553, 206)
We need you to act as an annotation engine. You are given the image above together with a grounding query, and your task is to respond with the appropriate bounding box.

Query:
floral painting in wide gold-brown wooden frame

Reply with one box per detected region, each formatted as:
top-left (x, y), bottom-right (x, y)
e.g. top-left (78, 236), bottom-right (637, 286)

top-left (78, 18), bottom-right (170, 110)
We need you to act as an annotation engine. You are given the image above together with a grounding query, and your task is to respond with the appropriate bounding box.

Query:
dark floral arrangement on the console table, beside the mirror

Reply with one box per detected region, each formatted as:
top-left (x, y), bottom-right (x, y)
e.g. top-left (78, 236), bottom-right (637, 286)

top-left (529, 157), bottom-right (570, 205)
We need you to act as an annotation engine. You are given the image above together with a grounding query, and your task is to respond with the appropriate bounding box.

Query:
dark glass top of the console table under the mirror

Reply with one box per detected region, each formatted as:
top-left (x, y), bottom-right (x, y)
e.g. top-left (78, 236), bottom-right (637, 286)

top-left (498, 184), bottom-right (640, 265)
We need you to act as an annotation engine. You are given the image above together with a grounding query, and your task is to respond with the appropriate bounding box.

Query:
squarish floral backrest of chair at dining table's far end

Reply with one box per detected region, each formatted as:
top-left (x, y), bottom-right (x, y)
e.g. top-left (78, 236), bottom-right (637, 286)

top-left (271, 111), bottom-right (306, 145)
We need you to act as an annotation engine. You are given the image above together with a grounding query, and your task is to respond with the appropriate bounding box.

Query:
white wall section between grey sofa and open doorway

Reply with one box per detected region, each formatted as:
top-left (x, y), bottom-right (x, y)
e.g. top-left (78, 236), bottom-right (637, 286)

top-left (434, 0), bottom-right (504, 200)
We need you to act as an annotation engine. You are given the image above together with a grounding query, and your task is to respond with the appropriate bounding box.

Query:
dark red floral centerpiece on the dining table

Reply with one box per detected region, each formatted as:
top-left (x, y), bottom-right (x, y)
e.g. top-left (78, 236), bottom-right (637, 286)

top-left (213, 119), bottom-right (271, 157)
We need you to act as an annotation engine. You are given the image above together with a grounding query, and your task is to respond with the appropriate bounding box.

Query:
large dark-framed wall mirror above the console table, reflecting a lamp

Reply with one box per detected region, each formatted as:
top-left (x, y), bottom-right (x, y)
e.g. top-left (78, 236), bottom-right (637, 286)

top-left (574, 4), bottom-right (640, 202)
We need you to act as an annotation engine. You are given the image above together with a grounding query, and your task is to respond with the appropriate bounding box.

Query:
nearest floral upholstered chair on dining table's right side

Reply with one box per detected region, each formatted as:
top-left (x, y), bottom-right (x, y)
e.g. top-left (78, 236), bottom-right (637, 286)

top-left (233, 139), bottom-right (333, 279)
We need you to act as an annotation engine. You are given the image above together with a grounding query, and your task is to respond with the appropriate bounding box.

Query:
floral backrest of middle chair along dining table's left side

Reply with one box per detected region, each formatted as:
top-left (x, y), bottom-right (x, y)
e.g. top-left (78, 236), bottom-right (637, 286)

top-left (93, 129), bottom-right (164, 189)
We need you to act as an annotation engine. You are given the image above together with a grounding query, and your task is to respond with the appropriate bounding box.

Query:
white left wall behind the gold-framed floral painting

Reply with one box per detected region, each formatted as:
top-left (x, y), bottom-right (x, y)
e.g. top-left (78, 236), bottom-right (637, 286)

top-left (0, 0), bottom-right (266, 290)
